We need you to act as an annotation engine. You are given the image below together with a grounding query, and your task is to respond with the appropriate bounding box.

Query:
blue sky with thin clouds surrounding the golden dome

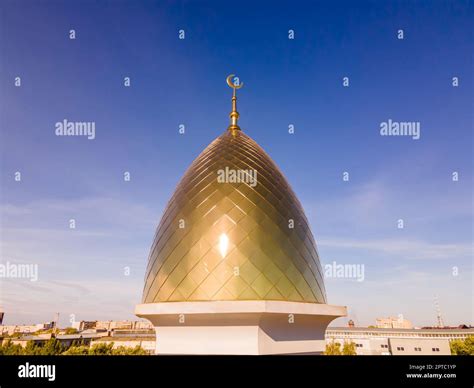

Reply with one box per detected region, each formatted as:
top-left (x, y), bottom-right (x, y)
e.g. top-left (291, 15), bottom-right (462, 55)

top-left (0, 1), bottom-right (474, 325)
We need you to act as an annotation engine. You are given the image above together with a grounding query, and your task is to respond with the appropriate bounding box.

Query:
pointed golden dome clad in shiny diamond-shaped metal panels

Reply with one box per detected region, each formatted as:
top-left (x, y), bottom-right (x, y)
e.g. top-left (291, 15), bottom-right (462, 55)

top-left (142, 131), bottom-right (326, 303)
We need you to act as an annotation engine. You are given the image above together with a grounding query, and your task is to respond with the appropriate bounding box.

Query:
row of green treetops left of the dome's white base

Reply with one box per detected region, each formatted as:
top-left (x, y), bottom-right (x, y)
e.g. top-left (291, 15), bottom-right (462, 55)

top-left (0, 338), bottom-right (148, 356)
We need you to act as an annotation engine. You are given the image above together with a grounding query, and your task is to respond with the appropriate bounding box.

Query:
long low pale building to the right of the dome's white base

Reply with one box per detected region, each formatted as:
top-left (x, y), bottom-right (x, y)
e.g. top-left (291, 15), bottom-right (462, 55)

top-left (326, 327), bottom-right (474, 355)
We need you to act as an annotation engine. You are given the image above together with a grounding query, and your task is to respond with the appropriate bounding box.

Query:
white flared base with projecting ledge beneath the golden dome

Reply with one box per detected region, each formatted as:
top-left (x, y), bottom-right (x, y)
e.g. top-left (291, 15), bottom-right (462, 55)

top-left (135, 301), bottom-right (347, 355)
